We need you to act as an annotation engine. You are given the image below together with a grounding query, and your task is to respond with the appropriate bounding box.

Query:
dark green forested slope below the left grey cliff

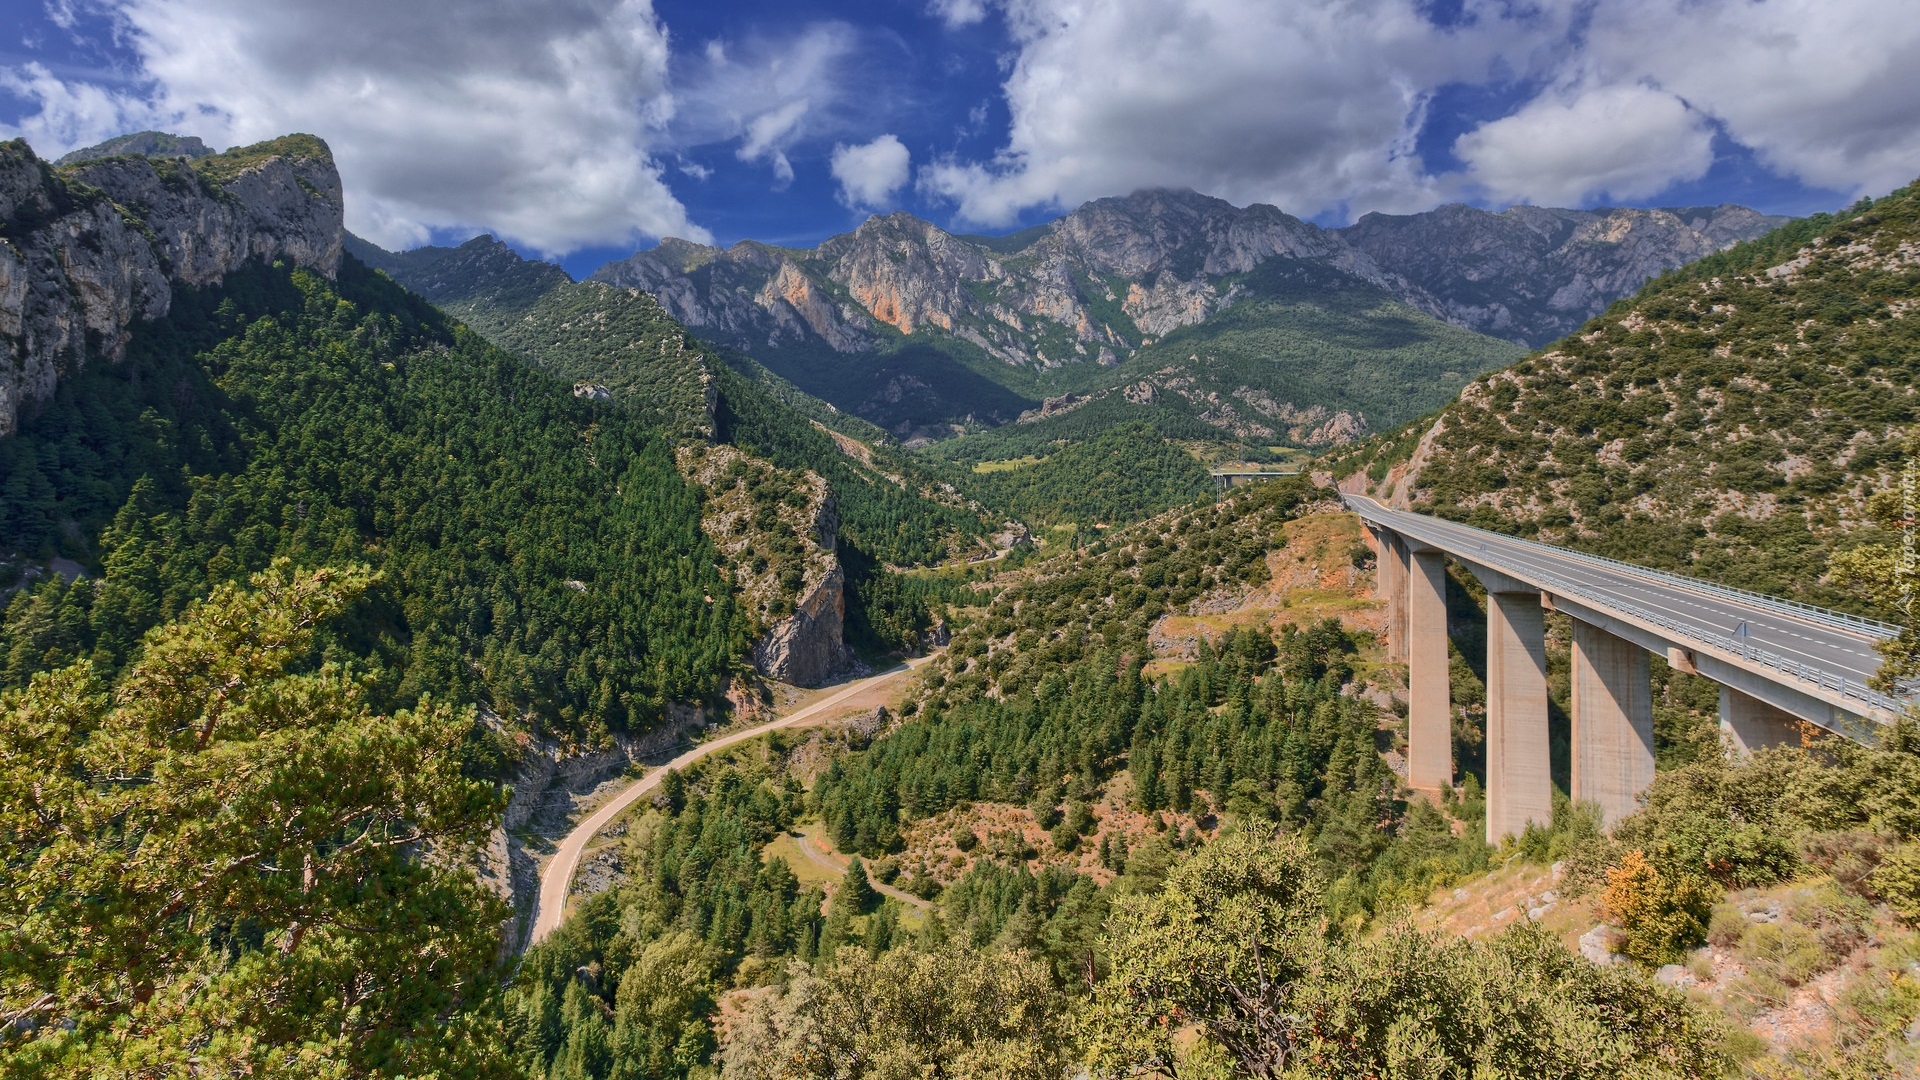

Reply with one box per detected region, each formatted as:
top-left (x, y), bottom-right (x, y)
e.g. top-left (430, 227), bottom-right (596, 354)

top-left (0, 259), bottom-right (745, 738)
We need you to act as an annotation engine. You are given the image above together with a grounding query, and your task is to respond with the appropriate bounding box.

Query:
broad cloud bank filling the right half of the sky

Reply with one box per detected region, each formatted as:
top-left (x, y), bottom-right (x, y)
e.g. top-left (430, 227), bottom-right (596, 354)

top-left (920, 0), bottom-right (1920, 225)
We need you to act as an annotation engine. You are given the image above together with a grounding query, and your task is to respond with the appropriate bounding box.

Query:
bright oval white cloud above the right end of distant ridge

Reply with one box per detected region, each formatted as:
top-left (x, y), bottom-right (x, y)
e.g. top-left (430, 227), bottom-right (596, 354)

top-left (1453, 85), bottom-right (1713, 206)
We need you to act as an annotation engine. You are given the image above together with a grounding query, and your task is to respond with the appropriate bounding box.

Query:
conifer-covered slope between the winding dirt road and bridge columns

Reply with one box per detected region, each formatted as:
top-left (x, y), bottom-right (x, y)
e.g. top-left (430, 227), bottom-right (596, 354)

top-left (812, 484), bottom-right (1486, 922)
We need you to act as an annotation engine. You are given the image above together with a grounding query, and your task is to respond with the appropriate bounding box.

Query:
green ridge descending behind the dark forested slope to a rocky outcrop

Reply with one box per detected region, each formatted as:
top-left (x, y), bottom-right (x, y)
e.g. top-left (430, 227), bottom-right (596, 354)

top-left (349, 236), bottom-right (991, 686)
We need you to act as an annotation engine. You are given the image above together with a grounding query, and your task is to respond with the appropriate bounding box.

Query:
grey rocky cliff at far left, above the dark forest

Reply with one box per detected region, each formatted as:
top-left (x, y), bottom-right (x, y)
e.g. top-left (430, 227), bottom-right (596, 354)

top-left (0, 136), bottom-right (344, 436)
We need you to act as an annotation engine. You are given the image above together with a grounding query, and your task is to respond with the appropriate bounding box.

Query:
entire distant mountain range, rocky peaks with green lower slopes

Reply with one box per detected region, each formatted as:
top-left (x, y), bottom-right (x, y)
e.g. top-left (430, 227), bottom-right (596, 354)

top-left (593, 190), bottom-right (1778, 446)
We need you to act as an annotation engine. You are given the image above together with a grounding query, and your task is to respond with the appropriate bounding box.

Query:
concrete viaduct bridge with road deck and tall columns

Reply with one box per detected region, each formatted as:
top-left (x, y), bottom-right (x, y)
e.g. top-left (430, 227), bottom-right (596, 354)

top-left (1344, 494), bottom-right (1910, 844)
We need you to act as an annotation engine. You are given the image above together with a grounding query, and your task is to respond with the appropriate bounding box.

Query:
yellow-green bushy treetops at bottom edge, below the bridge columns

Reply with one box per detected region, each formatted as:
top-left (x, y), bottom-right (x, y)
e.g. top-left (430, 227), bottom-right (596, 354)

top-left (1087, 832), bottom-right (1728, 1078)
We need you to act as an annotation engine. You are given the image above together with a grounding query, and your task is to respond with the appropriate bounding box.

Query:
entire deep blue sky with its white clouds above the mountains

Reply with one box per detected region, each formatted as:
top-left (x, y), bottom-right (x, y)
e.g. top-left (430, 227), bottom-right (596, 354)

top-left (0, 0), bottom-right (1920, 275)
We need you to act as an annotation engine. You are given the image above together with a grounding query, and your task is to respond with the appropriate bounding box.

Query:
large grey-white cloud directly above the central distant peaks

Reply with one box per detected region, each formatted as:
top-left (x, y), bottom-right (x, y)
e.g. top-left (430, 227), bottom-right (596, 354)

top-left (922, 0), bottom-right (1532, 225)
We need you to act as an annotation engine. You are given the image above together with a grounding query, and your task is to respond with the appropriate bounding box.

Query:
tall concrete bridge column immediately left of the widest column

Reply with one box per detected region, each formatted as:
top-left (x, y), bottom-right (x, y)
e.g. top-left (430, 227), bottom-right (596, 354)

top-left (1486, 590), bottom-right (1553, 844)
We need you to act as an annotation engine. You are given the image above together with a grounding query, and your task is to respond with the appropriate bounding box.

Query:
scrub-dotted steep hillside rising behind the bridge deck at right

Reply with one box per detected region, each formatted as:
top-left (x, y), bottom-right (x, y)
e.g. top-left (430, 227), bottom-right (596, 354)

top-left (1352, 186), bottom-right (1920, 617)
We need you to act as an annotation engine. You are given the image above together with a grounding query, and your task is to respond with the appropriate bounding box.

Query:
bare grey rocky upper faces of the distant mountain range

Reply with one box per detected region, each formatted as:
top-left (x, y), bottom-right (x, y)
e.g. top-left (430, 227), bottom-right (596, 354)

top-left (593, 190), bottom-right (1784, 369)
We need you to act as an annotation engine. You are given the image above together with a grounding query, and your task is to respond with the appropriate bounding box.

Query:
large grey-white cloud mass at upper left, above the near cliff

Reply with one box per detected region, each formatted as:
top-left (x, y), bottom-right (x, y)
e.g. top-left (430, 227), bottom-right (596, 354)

top-left (10, 0), bottom-right (707, 254)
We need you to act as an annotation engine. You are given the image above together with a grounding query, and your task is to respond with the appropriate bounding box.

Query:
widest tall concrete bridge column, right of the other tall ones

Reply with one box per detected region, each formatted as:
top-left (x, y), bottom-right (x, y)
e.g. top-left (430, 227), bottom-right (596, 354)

top-left (1572, 619), bottom-right (1653, 828)
